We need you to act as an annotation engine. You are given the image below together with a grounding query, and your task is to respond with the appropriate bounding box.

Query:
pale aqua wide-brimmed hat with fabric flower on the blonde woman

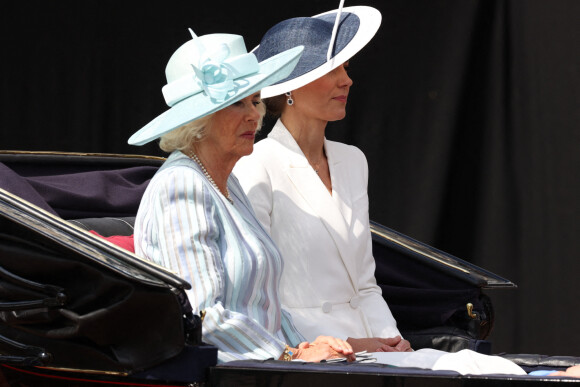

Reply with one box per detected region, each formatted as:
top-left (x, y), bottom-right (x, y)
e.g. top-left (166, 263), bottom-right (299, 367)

top-left (128, 30), bottom-right (303, 145)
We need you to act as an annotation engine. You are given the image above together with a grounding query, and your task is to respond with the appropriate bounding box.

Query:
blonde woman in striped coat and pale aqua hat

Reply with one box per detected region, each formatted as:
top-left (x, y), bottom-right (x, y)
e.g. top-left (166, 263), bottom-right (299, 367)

top-left (129, 32), bottom-right (353, 362)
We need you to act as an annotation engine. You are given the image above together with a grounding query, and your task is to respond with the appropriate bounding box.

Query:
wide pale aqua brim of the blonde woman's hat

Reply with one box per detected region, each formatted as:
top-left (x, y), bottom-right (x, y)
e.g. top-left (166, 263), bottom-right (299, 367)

top-left (128, 46), bottom-right (304, 145)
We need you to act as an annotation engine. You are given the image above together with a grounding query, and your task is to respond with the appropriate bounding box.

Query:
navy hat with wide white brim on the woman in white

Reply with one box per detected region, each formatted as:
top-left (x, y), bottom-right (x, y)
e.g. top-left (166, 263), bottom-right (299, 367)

top-left (252, 6), bottom-right (381, 98)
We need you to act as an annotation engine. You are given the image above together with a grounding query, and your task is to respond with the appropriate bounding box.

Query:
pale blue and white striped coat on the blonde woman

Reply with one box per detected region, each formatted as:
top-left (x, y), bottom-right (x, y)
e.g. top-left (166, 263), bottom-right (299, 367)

top-left (135, 152), bottom-right (304, 362)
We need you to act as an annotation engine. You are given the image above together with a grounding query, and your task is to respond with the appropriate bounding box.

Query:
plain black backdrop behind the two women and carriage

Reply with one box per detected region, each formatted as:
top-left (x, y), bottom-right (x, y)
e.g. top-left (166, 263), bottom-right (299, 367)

top-left (0, 0), bottom-right (580, 356)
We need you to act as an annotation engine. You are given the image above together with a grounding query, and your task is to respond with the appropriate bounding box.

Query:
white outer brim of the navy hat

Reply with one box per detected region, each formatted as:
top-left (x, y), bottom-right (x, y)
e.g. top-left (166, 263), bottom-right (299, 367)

top-left (252, 6), bottom-right (382, 98)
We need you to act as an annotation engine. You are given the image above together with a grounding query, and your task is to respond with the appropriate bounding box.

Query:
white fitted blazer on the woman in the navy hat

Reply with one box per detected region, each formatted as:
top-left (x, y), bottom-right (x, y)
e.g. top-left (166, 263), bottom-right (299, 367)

top-left (234, 120), bottom-right (400, 341)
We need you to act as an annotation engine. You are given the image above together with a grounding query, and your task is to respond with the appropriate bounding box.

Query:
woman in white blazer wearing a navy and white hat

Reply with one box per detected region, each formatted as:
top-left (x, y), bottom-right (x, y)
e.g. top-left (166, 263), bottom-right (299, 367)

top-left (234, 6), bottom-right (411, 352)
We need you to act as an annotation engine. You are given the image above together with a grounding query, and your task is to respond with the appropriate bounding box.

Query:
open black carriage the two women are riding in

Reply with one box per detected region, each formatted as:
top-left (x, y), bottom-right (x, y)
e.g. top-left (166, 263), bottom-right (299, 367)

top-left (0, 151), bottom-right (580, 386)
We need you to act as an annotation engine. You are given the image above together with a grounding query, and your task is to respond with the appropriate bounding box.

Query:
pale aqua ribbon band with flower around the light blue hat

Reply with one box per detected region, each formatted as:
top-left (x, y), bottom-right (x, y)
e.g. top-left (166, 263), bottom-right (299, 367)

top-left (161, 53), bottom-right (260, 106)
